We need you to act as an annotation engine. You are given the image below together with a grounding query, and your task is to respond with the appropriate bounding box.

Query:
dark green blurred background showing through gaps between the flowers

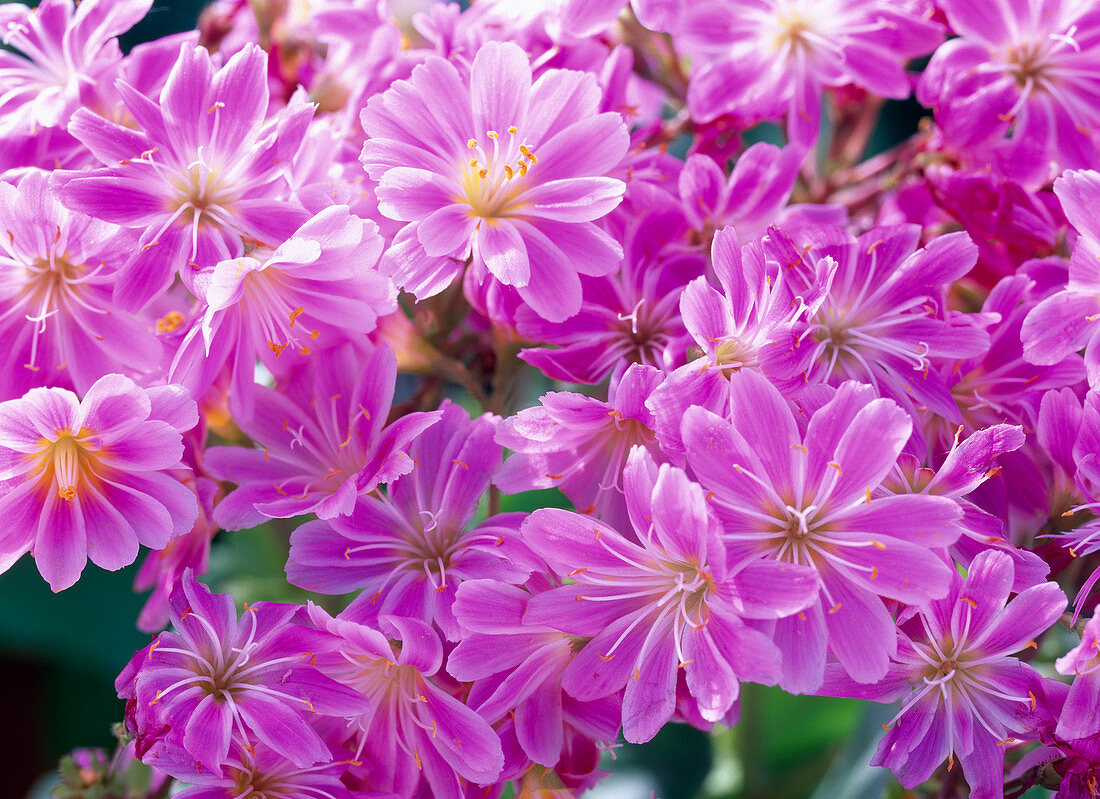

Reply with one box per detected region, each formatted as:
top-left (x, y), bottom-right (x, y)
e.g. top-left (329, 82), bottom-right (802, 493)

top-left (0, 0), bottom-right (922, 799)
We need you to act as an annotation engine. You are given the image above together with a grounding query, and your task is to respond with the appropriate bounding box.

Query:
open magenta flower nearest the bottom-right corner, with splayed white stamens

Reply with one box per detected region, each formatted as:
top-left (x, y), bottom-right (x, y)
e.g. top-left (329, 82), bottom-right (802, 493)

top-left (823, 551), bottom-right (1066, 799)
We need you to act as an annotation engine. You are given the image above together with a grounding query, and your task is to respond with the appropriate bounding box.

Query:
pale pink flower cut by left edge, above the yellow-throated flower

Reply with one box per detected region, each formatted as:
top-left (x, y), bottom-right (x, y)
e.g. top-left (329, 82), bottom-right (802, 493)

top-left (0, 171), bottom-right (161, 400)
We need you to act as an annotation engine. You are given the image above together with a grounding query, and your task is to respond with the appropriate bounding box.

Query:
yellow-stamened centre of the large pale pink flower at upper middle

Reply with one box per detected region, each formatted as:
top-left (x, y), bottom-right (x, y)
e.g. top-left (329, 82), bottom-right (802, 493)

top-left (457, 125), bottom-right (539, 219)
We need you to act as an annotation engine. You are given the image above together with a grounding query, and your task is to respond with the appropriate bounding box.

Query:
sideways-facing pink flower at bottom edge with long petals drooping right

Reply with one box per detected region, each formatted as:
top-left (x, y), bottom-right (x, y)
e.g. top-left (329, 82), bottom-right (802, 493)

top-left (310, 605), bottom-right (504, 799)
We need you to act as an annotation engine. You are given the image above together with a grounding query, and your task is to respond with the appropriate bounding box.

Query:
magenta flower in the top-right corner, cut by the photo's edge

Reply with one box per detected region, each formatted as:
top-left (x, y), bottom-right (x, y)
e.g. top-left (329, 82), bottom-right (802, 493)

top-left (919, 0), bottom-right (1100, 184)
